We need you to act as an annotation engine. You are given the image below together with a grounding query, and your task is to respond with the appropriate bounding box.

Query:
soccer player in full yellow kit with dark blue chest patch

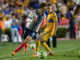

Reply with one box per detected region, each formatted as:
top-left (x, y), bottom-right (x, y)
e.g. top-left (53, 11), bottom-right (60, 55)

top-left (33, 9), bottom-right (58, 56)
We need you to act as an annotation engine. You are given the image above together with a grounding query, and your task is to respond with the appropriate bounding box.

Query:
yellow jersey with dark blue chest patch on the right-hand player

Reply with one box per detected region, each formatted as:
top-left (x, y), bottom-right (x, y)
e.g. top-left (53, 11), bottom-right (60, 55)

top-left (44, 12), bottom-right (58, 32)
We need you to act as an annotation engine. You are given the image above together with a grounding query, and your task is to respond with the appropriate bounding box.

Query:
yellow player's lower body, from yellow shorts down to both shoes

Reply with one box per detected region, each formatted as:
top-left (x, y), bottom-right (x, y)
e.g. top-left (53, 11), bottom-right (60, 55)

top-left (33, 32), bottom-right (54, 56)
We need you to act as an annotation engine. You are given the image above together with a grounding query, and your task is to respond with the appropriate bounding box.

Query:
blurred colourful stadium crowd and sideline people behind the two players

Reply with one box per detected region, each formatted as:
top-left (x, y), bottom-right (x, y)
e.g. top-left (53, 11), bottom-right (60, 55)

top-left (0, 0), bottom-right (80, 43)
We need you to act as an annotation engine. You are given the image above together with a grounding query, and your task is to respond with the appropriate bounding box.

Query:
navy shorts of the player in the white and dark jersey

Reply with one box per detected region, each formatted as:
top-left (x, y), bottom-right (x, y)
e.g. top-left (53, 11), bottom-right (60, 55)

top-left (23, 27), bottom-right (37, 39)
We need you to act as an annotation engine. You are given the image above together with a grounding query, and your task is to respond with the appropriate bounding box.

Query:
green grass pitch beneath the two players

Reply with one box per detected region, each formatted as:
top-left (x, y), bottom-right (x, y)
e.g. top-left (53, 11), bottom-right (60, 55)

top-left (0, 40), bottom-right (80, 60)
